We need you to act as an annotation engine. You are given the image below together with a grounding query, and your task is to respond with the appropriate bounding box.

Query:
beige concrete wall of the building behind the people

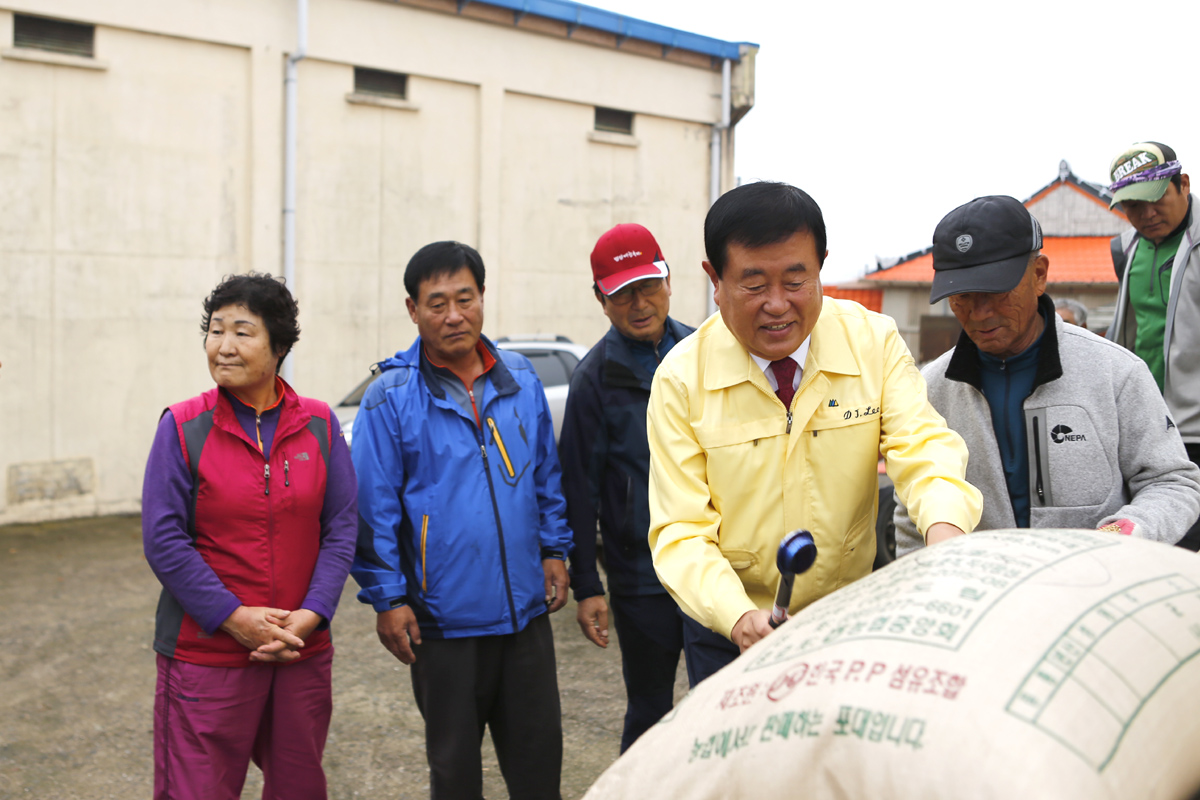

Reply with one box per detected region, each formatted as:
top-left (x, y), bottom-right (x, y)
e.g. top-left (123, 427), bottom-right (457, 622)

top-left (0, 0), bottom-right (745, 524)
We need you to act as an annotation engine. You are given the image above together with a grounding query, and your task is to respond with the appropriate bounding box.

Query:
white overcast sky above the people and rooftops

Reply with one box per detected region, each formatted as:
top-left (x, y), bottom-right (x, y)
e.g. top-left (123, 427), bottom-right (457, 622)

top-left (589, 0), bottom-right (1200, 283)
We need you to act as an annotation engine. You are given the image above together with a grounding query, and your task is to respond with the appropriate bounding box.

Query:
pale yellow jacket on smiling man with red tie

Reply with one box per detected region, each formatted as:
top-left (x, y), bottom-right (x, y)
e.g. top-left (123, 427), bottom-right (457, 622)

top-left (647, 297), bottom-right (982, 637)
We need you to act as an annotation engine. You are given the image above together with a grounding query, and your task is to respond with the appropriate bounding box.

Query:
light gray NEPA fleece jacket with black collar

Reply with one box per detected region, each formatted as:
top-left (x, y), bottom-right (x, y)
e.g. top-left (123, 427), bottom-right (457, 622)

top-left (895, 295), bottom-right (1200, 555)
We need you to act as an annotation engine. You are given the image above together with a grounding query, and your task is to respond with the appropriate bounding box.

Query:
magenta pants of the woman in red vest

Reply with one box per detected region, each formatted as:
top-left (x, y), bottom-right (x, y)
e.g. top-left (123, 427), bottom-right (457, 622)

top-left (154, 646), bottom-right (334, 800)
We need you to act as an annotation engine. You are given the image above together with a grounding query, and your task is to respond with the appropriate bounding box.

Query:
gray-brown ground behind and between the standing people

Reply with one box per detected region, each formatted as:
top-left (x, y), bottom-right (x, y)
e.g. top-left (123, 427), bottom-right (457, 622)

top-left (0, 517), bottom-right (686, 800)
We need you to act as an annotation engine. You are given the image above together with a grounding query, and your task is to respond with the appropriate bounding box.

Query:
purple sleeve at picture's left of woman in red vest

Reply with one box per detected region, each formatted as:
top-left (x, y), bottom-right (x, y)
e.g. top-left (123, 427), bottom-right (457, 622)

top-left (142, 411), bottom-right (241, 636)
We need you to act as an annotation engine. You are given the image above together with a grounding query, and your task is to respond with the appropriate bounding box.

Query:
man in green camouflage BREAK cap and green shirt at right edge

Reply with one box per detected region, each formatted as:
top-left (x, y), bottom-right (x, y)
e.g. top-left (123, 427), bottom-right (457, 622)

top-left (1108, 142), bottom-right (1200, 551)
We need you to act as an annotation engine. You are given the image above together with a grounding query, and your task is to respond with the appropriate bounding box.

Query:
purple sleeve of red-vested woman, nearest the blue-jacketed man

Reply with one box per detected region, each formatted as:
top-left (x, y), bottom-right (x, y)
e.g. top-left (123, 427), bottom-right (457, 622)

top-left (301, 414), bottom-right (359, 630)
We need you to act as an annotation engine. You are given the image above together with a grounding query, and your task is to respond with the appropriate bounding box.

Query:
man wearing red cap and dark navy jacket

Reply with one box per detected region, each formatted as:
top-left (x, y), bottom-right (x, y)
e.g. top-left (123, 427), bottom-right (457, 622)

top-left (558, 224), bottom-right (692, 752)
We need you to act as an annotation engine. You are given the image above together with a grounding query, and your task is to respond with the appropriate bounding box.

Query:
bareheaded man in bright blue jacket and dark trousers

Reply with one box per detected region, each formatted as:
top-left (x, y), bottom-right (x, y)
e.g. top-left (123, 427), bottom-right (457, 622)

top-left (352, 241), bottom-right (571, 799)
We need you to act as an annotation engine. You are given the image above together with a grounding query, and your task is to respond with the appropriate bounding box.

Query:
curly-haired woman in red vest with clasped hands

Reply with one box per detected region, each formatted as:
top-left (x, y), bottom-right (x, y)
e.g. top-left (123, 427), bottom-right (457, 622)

top-left (142, 273), bottom-right (358, 800)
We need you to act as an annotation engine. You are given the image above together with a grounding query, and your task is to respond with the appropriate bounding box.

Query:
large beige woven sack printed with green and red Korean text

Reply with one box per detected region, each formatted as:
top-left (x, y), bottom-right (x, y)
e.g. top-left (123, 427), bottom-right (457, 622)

top-left (587, 530), bottom-right (1200, 800)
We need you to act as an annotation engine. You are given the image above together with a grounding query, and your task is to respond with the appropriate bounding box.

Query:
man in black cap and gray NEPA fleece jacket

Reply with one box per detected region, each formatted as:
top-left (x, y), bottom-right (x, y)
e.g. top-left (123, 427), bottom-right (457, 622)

top-left (895, 197), bottom-right (1200, 553)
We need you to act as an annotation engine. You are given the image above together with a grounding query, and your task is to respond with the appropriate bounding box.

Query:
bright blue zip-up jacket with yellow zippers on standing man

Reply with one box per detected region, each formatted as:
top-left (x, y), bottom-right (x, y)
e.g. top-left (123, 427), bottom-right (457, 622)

top-left (350, 337), bottom-right (571, 638)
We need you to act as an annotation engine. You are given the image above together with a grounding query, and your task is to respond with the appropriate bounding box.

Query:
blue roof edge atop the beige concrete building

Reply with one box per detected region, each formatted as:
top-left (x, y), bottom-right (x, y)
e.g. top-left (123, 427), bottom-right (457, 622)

top-left (458, 0), bottom-right (758, 61)
